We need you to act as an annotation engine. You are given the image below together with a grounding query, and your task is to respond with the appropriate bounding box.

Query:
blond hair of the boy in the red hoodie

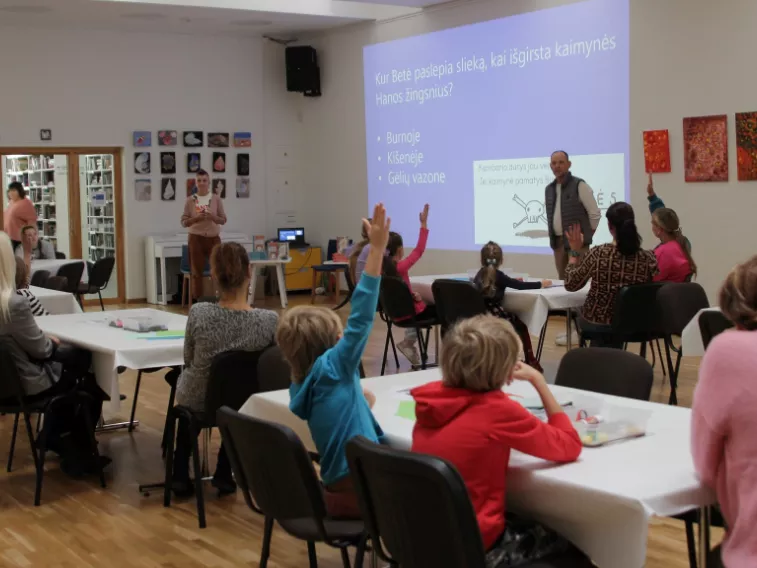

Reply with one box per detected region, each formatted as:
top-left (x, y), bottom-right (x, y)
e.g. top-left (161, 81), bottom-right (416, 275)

top-left (442, 315), bottom-right (523, 392)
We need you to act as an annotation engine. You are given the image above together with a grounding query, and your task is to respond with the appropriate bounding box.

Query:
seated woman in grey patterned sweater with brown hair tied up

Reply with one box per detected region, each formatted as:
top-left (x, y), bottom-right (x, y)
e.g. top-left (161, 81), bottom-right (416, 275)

top-left (172, 243), bottom-right (279, 497)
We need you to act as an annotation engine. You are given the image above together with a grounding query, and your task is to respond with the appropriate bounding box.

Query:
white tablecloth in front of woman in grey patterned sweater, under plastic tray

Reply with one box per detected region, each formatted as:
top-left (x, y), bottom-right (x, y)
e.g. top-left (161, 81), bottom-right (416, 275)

top-left (37, 308), bottom-right (187, 412)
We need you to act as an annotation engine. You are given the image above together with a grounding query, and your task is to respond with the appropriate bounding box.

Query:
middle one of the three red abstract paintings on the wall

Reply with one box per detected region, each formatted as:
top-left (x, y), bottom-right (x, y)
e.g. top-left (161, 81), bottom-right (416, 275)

top-left (683, 114), bottom-right (728, 181)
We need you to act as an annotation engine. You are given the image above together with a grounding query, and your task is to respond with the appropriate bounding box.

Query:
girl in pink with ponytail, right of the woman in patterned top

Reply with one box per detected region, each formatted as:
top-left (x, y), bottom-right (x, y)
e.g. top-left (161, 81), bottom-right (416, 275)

top-left (652, 207), bottom-right (697, 282)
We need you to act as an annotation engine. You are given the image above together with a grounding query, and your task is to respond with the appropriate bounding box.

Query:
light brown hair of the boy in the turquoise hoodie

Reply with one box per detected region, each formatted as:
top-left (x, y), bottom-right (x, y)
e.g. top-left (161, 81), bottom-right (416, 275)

top-left (276, 306), bottom-right (343, 383)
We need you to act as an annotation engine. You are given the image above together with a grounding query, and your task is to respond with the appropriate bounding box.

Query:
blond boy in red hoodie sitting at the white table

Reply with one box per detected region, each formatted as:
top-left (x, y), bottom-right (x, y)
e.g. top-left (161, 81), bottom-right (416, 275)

top-left (411, 315), bottom-right (591, 568)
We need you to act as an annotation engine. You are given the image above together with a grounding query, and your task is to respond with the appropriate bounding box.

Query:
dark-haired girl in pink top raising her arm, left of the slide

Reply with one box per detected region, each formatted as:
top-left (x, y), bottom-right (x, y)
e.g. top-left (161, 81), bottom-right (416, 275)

top-left (384, 203), bottom-right (436, 365)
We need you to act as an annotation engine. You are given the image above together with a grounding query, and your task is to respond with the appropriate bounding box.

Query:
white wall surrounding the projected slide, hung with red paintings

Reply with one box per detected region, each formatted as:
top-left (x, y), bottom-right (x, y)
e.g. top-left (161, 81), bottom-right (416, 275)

top-left (300, 0), bottom-right (757, 298)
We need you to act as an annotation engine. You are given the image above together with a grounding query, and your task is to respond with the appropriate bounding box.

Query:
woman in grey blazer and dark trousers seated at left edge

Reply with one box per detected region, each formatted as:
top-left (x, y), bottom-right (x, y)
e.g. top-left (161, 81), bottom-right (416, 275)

top-left (0, 232), bottom-right (107, 477)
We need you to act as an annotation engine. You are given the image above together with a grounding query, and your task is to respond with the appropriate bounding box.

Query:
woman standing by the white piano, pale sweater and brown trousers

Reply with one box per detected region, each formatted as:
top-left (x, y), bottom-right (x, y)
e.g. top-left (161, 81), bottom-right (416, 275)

top-left (181, 170), bottom-right (226, 301)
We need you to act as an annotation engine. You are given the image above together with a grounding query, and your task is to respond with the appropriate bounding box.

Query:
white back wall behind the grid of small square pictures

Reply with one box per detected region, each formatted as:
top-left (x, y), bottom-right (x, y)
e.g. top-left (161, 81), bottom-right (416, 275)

top-left (0, 28), bottom-right (297, 298)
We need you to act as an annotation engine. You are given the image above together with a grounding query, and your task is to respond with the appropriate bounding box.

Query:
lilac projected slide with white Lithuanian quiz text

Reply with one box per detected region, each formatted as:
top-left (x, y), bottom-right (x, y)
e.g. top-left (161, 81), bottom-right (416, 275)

top-left (363, 0), bottom-right (629, 253)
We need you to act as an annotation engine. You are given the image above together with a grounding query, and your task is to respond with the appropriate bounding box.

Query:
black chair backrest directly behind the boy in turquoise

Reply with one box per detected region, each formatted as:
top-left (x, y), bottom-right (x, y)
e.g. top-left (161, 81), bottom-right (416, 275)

top-left (217, 407), bottom-right (326, 541)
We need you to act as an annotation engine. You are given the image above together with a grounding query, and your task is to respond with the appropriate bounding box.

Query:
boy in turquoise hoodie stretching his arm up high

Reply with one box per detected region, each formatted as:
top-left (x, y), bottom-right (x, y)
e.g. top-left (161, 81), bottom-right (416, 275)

top-left (276, 204), bottom-right (389, 519)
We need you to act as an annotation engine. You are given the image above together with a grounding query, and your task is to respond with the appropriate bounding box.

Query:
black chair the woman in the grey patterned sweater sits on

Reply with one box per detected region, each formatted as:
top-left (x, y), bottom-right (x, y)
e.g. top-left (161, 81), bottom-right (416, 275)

top-left (163, 351), bottom-right (263, 529)
